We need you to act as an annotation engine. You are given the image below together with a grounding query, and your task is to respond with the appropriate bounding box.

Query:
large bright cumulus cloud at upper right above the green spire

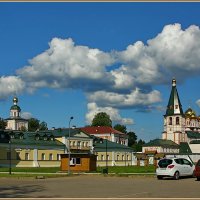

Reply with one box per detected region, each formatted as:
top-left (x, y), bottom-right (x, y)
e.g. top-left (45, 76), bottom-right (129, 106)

top-left (111, 24), bottom-right (200, 88)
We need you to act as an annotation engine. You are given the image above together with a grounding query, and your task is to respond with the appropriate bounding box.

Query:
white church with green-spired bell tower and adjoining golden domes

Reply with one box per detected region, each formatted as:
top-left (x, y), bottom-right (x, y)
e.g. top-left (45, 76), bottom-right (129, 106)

top-left (162, 79), bottom-right (200, 153)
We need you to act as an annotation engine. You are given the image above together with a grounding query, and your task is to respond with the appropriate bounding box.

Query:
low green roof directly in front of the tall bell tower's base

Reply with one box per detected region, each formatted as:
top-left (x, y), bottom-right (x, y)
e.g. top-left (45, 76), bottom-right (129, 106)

top-left (143, 139), bottom-right (179, 148)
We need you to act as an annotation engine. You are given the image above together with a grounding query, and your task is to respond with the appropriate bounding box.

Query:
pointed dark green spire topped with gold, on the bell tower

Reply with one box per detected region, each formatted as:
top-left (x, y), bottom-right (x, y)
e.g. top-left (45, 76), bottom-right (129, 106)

top-left (166, 78), bottom-right (183, 116)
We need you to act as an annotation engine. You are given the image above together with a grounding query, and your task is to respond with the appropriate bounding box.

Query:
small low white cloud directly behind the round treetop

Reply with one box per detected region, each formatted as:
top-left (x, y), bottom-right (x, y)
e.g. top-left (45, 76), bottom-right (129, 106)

top-left (86, 103), bottom-right (134, 125)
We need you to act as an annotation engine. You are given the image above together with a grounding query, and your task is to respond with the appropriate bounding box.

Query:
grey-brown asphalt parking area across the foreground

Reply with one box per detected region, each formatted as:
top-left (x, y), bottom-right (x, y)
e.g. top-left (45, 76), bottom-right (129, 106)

top-left (0, 175), bottom-right (200, 200)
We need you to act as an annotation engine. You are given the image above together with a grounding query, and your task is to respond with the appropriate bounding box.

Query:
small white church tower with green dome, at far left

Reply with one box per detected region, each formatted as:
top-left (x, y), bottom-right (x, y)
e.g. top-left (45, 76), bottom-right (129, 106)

top-left (6, 97), bottom-right (28, 130)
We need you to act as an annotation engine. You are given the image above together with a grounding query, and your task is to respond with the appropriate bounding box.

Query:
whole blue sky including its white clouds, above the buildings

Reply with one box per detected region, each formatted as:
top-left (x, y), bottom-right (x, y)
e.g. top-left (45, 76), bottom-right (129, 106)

top-left (0, 2), bottom-right (200, 141)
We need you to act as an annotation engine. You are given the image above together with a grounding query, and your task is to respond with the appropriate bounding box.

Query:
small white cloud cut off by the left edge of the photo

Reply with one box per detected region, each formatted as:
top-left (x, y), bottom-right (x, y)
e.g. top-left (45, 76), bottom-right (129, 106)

top-left (0, 76), bottom-right (25, 100)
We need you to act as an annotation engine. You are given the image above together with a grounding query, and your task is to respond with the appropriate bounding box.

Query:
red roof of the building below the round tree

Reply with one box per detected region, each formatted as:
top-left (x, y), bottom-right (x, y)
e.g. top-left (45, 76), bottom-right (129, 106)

top-left (80, 126), bottom-right (125, 135)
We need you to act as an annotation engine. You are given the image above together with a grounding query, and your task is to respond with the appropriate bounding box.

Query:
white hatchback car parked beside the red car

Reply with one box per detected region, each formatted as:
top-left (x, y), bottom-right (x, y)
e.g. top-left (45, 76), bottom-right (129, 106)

top-left (156, 158), bottom-right (195, 180)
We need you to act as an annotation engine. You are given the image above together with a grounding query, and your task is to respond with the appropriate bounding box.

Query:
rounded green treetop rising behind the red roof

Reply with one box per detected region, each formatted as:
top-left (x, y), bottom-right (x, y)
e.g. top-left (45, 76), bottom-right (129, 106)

top-left (91, 112), bottom-right (112, 127)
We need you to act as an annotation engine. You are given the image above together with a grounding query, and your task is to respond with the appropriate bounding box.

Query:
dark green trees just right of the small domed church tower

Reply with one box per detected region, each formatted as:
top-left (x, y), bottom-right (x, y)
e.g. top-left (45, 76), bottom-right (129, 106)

top-left (28, 118), bottom-right (48, 131)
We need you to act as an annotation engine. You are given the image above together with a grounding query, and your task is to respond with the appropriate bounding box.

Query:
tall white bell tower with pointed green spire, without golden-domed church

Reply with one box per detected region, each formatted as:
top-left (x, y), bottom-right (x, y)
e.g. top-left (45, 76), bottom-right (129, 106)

top-left (162, 79), bottom-right (186, 144)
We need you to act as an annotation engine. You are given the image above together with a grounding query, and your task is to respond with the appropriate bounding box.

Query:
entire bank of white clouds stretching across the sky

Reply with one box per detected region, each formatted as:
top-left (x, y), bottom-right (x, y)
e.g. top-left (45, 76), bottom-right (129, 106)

top-left (0, 23), bottom-right (200, 124)
